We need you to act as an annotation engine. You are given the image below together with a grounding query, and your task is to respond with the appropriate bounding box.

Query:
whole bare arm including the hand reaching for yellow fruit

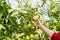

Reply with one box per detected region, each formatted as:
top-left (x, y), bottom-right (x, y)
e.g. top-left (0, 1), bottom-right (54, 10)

top-left (35, 20), bottom-right (54, 37)
